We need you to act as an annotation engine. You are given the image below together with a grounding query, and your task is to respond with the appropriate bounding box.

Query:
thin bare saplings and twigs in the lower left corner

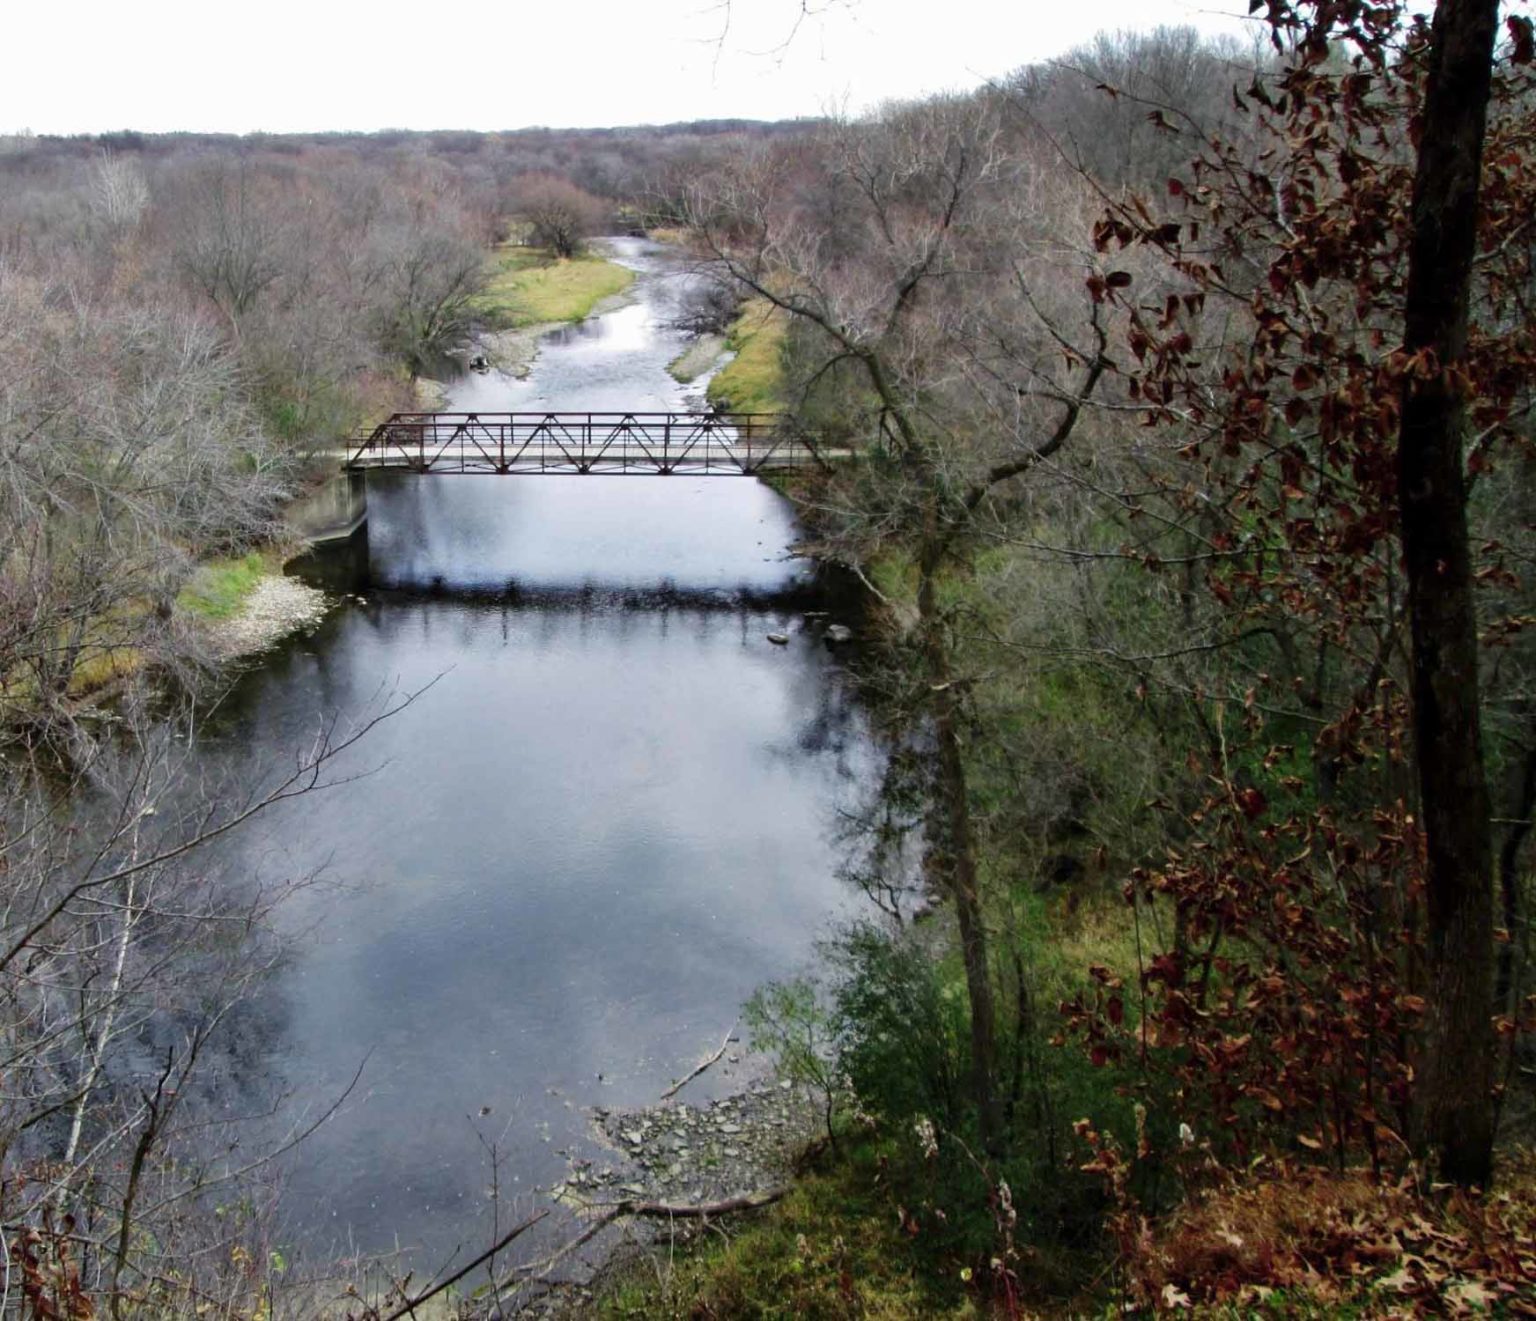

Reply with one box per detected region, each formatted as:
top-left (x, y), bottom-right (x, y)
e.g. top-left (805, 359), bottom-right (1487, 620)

top-left (0, 685), bottom-right (410, 1316)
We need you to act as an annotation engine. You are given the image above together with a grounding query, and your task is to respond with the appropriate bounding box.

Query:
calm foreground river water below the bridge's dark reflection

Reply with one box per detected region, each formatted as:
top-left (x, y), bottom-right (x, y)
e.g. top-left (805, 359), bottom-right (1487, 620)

top-left (216, 586), bottom-right (872, 1247)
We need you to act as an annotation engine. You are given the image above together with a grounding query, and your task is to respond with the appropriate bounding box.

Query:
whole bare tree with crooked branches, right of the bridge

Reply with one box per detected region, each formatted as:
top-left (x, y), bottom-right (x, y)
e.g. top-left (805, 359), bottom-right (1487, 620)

top-left (691, 98), bottom-right (1107, 1152)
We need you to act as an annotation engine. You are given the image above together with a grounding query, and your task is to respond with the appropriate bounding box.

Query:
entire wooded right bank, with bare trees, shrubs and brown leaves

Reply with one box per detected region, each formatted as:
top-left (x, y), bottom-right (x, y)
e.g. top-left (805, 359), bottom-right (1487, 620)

top-left (608, 5), bottom-right (1536, 1315)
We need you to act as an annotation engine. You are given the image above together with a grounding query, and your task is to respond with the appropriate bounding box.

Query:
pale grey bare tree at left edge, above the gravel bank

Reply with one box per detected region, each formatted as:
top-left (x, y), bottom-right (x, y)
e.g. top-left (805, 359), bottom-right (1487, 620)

top-left (0, 264), bottom-right (292, 728)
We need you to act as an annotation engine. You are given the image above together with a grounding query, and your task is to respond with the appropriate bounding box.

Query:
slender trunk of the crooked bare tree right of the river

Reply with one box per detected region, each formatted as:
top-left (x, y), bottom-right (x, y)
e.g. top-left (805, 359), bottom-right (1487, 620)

top-left (917, 516), bottom-right (1003, 1155)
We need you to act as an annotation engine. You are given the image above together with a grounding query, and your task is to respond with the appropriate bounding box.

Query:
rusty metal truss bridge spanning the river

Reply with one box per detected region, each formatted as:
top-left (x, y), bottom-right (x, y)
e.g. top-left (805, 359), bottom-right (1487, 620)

top-left (344, 413), bottom-right (823, 476)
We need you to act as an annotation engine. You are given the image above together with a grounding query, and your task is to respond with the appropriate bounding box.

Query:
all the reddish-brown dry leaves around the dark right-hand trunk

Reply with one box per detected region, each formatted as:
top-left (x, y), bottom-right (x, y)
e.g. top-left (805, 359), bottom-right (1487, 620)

top-left (1069, 5), bottom-right (1536, 1170)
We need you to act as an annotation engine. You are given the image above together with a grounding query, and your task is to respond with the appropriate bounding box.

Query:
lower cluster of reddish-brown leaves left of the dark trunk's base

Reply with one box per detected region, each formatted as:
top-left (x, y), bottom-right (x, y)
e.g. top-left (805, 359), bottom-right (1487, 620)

top-left (1066, 777), bottom-right (1424, 1169)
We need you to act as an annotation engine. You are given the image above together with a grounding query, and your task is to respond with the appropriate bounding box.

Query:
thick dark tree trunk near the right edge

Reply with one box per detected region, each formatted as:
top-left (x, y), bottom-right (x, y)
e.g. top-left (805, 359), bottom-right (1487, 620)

top-left (1398, 0), bottom-right (1498, 1186)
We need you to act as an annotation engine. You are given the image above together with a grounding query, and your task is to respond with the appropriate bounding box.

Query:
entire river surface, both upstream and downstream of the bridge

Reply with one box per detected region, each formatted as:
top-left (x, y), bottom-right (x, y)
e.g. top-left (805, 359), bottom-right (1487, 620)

top-left (207, 240), bottom-right (877, 1273)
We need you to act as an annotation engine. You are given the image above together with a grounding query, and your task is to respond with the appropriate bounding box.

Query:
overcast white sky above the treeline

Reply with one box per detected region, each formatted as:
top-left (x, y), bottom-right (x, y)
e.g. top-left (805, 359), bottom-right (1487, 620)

top-left (0, 0), bottom-right (1247, 134)
